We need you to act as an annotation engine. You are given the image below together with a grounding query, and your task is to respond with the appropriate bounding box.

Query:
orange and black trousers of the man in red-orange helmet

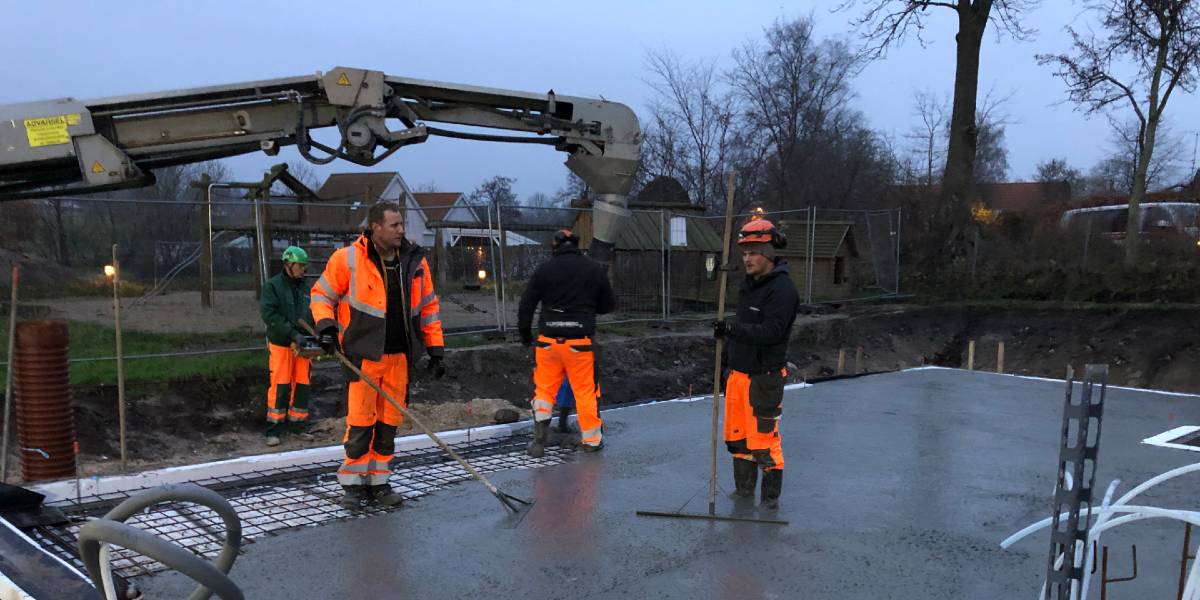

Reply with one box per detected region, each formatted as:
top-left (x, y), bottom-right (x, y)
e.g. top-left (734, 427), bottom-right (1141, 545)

top-left (725, 370), bottom-right (787, 470)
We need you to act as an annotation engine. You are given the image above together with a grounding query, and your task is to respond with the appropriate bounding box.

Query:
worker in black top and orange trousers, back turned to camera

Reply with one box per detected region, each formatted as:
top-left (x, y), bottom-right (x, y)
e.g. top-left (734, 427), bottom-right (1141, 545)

top-left (517, 229), bottom-right (617, 458)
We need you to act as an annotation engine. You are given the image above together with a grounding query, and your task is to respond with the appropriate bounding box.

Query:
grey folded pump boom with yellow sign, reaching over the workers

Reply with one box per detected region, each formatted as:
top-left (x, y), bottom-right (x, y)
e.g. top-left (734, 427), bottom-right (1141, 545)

top-left (0, 67), bottom-right (641, 260)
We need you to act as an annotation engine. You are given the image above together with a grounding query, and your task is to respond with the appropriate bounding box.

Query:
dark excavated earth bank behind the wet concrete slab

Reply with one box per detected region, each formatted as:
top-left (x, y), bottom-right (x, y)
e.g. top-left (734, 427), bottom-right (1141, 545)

top-left (2, 306), bottom-right (1200, 482)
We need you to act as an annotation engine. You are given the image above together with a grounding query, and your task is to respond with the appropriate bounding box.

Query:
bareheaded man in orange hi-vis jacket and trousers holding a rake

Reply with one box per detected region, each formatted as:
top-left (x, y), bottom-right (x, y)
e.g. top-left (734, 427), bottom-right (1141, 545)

top-left (312, 202), bottom-right (445, 510)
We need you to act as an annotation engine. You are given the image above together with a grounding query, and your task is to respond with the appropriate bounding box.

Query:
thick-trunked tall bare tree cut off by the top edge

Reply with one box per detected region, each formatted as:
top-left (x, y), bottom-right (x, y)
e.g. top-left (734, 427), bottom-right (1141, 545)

top-left (841, 0), bottom-right (1040, 221)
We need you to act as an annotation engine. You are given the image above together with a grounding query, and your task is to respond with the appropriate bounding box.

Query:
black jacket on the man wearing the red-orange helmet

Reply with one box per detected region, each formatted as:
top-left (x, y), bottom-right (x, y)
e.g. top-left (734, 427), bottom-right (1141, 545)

top-left (727, 260), bottom-right (800, 374)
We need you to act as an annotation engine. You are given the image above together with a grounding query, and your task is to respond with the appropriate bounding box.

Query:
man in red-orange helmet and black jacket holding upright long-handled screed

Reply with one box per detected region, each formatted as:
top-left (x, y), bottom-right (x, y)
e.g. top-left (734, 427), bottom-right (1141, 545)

top-left (713, 218), bottom-right (800, 508)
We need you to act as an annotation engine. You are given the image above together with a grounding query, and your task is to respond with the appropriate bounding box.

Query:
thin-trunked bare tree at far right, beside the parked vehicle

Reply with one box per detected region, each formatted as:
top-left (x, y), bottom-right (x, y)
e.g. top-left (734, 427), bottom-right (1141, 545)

top-left (1038, 0), bottom-right (1200, 265)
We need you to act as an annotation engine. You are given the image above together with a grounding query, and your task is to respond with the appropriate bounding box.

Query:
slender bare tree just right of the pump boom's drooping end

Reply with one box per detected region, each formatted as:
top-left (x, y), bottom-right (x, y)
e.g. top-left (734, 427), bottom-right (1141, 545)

top-left (646, 50), bottom-right (734, 212)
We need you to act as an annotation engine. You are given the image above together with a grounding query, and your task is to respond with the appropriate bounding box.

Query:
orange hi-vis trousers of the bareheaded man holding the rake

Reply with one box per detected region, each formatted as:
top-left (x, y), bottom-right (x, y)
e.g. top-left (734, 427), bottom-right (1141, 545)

top-left (337, 354), bottom-right (408, 486)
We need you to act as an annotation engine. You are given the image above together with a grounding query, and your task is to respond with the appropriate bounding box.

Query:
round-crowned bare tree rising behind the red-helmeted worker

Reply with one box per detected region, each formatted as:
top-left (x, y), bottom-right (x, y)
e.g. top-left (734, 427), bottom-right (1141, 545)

top-left (730, 17), bottom-right (860, 208)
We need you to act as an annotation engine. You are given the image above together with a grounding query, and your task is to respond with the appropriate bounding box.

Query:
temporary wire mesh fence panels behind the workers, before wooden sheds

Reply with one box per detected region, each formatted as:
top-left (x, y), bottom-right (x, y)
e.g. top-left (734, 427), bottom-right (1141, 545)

top-left (4, 194), bottom-right (901, 360)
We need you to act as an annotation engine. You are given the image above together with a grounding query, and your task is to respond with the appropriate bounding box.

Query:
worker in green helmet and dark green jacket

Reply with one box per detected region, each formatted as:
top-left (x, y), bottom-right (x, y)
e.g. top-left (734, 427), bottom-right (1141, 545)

top-left (259, 246), bottom-right (312, 446)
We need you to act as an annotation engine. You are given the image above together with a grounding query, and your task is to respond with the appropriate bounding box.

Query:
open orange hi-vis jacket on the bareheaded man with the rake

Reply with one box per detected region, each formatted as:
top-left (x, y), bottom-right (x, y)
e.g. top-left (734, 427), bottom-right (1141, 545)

top-left (312, 235), bottom-right (445, 361)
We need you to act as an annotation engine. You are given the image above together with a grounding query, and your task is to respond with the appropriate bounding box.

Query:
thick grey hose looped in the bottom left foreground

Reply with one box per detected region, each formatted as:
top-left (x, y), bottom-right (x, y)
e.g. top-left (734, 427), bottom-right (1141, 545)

top-left (78, 484), bottom-right (244, 600)
